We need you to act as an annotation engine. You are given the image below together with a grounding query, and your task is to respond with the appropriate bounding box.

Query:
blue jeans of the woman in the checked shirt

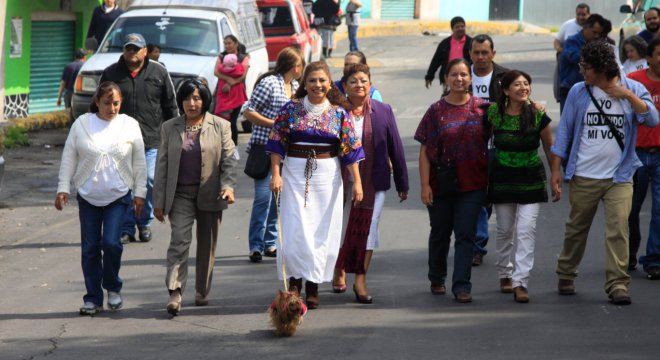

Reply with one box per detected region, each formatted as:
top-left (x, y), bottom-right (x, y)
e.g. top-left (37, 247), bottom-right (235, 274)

top-left (248, 172), bottom-right (277, 252)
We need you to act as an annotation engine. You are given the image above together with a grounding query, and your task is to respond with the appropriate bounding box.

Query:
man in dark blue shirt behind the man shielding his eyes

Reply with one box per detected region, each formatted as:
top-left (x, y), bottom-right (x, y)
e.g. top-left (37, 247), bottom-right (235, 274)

top-left (559, 14), bottom-right (612, 112)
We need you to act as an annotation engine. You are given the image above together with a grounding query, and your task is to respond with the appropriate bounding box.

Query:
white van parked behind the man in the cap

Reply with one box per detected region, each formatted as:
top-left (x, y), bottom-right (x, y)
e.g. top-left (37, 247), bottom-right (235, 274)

top-left (71, 0), bottom-right (268, 118)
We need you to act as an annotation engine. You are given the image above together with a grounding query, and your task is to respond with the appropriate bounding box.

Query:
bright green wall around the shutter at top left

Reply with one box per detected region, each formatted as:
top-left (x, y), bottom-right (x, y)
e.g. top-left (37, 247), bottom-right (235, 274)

top-left (3, 0), bottom-right (99, 95)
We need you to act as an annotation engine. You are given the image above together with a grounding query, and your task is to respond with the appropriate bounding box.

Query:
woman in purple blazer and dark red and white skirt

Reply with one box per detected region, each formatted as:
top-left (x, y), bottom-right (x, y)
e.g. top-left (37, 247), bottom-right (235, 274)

top-left (332, 64), bottom-right (408, 304)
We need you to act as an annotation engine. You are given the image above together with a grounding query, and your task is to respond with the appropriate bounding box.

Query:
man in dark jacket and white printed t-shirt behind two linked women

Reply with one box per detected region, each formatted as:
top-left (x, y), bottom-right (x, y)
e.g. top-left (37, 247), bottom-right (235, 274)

top-left (470, 34), bottom-right (509, 266)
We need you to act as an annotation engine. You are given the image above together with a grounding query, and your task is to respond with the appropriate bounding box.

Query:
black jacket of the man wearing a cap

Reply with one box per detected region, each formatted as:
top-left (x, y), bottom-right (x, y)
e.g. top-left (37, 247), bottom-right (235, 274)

top-left (100, 56), bottom-right (179, 148)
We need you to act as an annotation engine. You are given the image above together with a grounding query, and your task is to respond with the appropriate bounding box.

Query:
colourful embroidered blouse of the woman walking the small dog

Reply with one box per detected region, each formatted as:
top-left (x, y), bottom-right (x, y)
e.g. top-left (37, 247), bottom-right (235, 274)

top-left (266, 100), bottom-right (364, 165)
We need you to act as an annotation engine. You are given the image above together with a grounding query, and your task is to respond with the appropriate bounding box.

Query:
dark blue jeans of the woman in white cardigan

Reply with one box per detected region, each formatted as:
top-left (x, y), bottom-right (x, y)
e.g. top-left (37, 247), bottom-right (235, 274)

top-left (78, 191), bottom-right (132, 306)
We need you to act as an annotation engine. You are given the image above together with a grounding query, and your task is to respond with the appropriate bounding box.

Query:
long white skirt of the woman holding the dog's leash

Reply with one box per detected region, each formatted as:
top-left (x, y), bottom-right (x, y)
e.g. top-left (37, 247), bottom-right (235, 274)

top-left (277, 157), bottom-right (343, 283)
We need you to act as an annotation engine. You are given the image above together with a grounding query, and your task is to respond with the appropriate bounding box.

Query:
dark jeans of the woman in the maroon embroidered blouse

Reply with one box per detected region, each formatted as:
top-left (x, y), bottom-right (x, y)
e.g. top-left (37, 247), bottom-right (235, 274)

top-left (427, 190), bottom-right (486, 294)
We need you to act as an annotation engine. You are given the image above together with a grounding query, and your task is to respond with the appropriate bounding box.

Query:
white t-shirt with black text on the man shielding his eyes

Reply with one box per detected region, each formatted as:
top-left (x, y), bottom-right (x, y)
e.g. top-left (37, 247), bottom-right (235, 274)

top-left (575, 86), bottom-right (626, 179)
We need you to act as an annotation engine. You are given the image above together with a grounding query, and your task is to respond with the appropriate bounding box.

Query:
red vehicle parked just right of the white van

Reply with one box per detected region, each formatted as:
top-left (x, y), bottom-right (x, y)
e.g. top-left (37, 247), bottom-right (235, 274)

top-left (257, 0), bottom-right (321, 68)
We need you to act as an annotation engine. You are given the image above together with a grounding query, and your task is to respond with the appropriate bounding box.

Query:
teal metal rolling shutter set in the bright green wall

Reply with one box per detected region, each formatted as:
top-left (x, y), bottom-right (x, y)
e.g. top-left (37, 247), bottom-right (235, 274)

top-left (28, 21), bottom-right (75, 114)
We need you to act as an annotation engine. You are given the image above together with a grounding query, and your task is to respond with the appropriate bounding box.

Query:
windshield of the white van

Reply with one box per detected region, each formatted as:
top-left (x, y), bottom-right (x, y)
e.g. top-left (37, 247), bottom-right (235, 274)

top-left (99, 16), bottom-right (220, 56)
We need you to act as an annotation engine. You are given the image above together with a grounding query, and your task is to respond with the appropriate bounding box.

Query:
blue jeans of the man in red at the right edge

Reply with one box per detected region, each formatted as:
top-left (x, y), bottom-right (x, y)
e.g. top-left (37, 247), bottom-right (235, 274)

top-left (628, 149), bottom-right (660, 269)
